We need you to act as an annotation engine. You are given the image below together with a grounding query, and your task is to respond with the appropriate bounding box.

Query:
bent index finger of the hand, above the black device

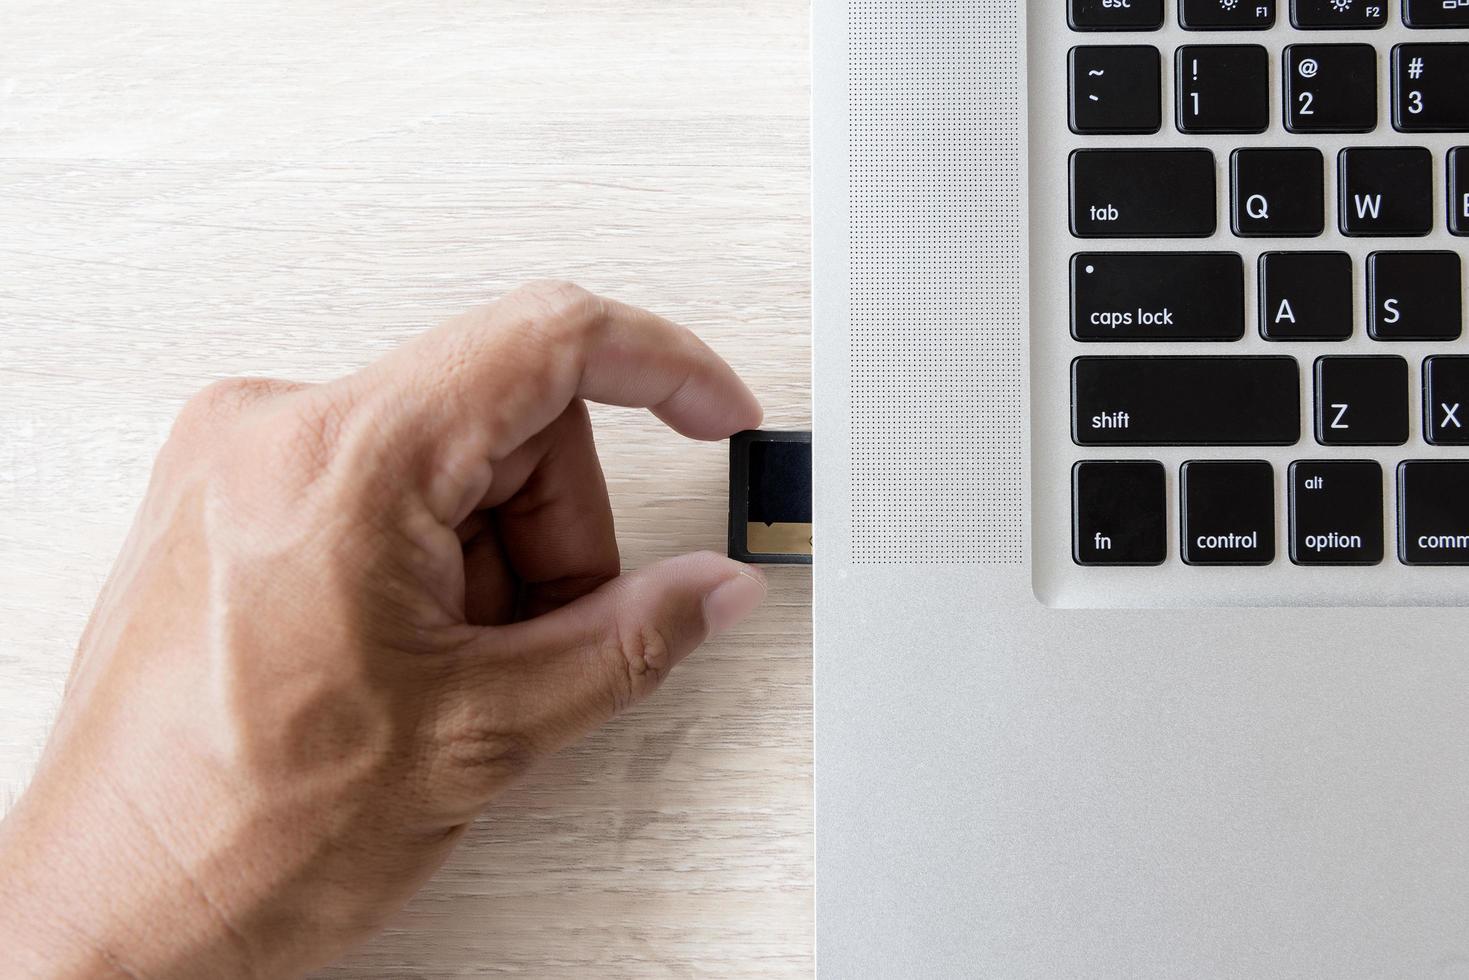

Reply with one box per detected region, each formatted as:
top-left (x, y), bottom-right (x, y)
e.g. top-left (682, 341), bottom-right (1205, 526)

top-left (342, 282), bottom-right (762, 461)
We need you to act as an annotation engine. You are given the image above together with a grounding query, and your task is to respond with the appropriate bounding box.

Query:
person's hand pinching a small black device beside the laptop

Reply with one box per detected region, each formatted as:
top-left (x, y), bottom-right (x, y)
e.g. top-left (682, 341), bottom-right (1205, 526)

top-left (0, 284), bottom-right (764, 977)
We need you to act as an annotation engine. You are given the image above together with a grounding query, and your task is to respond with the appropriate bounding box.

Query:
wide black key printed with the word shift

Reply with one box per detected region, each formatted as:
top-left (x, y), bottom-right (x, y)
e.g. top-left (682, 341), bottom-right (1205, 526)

top-left (1071, 356), bottom-right (1300, 445)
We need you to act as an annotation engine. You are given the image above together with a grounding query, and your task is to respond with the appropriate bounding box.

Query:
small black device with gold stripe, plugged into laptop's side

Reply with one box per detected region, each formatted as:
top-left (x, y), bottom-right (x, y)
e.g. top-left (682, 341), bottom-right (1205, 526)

top-left (729, 430), bottom-right (811, 564)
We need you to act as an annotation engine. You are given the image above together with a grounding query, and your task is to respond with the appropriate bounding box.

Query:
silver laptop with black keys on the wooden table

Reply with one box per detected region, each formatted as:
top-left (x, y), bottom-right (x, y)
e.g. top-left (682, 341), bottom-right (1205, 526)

top-left (812, 0), bottom-right (1469, 977)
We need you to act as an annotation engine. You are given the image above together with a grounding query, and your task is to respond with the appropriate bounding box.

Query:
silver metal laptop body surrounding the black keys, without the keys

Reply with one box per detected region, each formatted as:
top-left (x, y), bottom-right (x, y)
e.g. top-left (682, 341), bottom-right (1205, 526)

top-left (812, 0), bottom-right (1469, 977)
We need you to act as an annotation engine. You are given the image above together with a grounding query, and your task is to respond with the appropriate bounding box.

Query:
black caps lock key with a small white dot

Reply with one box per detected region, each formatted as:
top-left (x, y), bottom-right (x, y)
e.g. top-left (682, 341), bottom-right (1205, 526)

top-left (1071, 251), bottom-right (1244, 341)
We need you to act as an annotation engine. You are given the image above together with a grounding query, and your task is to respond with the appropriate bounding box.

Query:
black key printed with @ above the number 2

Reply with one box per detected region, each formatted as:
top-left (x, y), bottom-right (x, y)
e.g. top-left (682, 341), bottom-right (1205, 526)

top-left (1284, 44), bottom-right (1376, 132)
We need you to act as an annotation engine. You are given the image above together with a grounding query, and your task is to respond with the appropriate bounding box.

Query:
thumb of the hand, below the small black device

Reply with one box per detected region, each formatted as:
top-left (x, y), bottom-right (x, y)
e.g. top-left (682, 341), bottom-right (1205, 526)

top-left (495, 551), bottom-right (765, 748)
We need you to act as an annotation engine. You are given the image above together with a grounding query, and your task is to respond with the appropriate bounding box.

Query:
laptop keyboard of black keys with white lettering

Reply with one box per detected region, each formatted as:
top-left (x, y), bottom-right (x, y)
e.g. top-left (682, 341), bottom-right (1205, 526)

top-left (1062, 0), bottom-right (1469, 566)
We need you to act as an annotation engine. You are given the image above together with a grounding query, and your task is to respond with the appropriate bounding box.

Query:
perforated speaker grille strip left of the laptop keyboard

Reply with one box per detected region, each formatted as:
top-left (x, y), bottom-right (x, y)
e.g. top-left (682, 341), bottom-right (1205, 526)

top-left (848, 0), bottom-right (1025, 564)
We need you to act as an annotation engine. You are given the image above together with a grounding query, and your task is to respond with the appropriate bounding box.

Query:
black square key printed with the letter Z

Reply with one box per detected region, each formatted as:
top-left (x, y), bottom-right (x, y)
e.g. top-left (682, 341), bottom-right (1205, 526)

top-left (1315, 356), bottom-right (1407, 445)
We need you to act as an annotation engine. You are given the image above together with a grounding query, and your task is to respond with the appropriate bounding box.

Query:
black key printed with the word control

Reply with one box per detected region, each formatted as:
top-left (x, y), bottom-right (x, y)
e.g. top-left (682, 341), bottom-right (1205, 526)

top-left (1180, 460), bottom-right (1275, 564)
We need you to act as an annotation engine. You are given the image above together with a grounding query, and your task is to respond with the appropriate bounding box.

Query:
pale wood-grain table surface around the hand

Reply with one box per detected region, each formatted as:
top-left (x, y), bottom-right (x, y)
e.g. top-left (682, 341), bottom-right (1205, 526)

top-left (0, 0), bottom-right (812, 977)
